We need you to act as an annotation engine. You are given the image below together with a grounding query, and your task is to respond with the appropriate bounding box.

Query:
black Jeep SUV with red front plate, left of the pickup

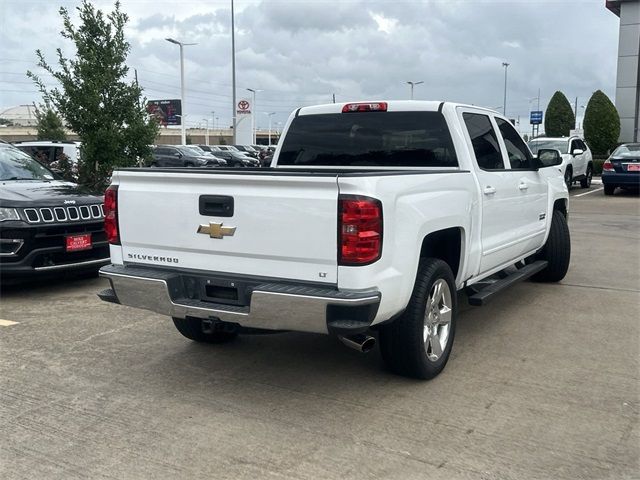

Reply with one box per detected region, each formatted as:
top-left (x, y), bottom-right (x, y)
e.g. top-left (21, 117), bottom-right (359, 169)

top-left (0, 144), bottom-right (109, 280)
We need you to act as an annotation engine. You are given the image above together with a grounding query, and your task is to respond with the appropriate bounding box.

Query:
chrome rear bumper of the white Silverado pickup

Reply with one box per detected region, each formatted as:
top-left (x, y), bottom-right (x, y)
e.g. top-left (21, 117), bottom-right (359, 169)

top-left (100, 265), bottom-right (380, 333)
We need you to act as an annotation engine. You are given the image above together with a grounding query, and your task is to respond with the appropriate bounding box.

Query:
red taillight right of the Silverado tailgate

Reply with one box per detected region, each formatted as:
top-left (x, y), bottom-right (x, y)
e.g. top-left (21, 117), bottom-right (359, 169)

top-left (338, 195), bottom-right (382, 265)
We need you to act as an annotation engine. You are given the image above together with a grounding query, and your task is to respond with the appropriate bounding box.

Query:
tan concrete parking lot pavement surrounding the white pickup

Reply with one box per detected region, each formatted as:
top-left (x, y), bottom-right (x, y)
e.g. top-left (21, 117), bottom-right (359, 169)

top-left (0, 185), bottom-right (640, 480)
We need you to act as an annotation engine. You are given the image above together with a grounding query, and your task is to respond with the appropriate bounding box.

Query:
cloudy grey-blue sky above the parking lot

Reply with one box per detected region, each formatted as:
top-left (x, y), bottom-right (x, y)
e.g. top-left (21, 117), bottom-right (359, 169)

top-left (0, 0), bottom-right (618, 132)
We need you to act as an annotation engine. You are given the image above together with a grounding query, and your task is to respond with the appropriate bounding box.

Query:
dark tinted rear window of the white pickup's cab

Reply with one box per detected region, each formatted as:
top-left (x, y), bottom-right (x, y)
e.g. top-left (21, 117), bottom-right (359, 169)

top-left (273, 112), bottom-right (458, 167)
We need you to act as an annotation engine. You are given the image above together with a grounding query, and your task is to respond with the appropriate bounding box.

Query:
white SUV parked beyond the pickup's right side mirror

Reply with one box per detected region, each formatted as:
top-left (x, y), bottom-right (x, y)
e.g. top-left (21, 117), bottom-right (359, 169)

top-left (529, 136), bottom-right (593, 188)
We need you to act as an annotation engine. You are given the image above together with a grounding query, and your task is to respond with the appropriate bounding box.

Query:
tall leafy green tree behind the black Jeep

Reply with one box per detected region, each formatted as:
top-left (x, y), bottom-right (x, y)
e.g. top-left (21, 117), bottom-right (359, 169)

top-left (27, 0), bottom-right (158, 188)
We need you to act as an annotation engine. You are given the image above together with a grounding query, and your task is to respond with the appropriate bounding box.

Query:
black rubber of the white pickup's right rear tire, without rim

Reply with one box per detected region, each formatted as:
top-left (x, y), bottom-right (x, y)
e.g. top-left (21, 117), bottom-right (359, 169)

top-left (379, 258), bottom-right (458, 380)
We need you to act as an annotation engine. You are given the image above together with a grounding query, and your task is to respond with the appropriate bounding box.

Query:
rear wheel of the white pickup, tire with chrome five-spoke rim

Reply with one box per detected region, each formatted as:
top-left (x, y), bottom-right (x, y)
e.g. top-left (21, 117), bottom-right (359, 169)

top-left (380, 258), bottom-right (458, 379)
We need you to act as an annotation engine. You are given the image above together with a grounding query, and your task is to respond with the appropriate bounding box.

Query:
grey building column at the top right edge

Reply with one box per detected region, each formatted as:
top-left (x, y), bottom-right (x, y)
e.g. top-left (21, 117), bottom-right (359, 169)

top-left (606, 0), bottom-right (640, 142)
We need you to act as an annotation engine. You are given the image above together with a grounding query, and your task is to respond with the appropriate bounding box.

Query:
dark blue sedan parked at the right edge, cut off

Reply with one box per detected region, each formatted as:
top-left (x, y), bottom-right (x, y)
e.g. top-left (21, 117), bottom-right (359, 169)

top-left (602, 143), bottom-right (640, 195)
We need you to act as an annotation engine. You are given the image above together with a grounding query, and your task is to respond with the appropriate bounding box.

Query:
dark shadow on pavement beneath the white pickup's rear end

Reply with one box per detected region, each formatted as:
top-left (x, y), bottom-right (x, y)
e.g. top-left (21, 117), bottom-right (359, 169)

top-left (136, 294), bottom-right (484, 392)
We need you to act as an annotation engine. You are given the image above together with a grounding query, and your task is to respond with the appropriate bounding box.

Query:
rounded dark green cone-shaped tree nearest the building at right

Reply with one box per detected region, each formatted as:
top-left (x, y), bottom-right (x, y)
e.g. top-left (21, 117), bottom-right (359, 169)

top-left (583, 90), bottom-right (620, 155)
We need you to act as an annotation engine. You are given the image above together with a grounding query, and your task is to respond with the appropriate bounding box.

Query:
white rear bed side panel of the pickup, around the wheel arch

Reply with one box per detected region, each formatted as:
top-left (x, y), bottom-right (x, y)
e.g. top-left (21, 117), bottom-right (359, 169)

top-left (338, 171), bottom-right (477, 323)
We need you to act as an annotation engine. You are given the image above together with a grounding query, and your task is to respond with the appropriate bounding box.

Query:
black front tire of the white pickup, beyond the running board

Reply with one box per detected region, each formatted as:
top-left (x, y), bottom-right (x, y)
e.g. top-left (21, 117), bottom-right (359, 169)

top-left (532, 210), bottom-right (571, 282)
